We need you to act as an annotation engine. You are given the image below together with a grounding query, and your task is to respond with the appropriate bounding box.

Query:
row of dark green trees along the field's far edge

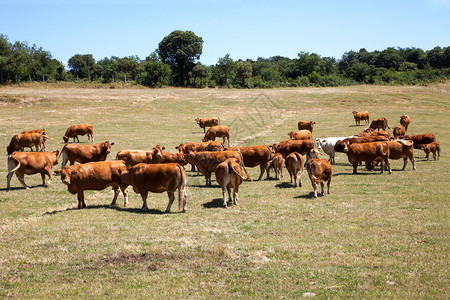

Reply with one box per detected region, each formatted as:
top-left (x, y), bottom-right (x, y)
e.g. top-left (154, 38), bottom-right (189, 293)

top-left (0, 30), bottom-right (450, 88)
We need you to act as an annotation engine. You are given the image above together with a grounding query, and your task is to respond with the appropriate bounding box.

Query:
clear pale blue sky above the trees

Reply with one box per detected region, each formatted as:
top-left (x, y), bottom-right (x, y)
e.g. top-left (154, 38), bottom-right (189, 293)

top-left (0, 0), bottom-right (450, 65)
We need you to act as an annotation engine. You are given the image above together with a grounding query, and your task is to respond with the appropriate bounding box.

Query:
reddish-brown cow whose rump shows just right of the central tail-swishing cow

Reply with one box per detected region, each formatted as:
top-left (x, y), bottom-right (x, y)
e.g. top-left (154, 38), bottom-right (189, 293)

top-left (225, 145), bottom-right (270, 180)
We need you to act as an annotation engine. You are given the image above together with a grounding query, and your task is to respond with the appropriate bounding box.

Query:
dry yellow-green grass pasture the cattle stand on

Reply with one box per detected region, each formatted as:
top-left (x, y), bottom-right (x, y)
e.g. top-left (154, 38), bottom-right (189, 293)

top-left (0, 82), bottom-right (450, 299)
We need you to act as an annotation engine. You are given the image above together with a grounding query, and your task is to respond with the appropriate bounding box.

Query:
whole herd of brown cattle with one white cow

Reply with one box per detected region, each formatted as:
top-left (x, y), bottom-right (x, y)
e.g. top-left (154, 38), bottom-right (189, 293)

top-left (7, 111), bottom-right (440, 212)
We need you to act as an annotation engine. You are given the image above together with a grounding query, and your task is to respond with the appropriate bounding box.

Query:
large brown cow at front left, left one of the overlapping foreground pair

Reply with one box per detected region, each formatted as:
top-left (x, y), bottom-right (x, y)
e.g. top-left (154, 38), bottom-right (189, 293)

top-left (55, 160), bottom-right (128, 208)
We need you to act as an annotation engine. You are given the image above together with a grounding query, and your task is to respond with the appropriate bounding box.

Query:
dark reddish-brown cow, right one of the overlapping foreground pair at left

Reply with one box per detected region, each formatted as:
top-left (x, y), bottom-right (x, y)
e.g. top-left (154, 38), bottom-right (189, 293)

top-left (119, 163), bottom-right (187, 213)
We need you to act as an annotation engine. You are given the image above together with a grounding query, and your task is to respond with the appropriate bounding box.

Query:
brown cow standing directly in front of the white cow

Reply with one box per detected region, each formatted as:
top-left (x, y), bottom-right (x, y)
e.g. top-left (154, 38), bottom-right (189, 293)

top-left (306, 149), bottom-right (333, 198)
